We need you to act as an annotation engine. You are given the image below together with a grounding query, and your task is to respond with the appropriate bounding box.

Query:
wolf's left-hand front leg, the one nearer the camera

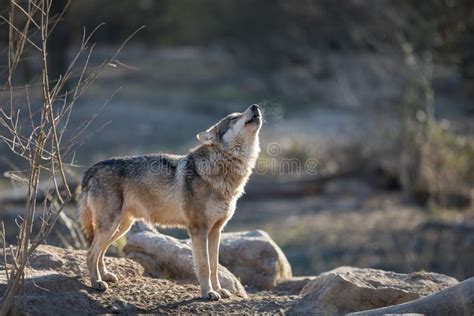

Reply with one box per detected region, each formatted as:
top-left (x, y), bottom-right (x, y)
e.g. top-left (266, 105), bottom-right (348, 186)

top-left (190, 230), bottom-right (221, 300)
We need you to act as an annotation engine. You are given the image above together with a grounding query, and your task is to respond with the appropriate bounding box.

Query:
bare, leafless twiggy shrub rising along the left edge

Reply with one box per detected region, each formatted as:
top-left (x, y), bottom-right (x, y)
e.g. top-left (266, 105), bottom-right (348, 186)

top-left (0, 0), bottom-right (141, 315)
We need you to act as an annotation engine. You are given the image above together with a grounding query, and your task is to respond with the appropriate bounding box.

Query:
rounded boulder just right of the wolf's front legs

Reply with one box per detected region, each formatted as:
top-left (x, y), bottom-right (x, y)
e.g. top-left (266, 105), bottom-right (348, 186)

top-left (219, 230), bottom-right (292, 290)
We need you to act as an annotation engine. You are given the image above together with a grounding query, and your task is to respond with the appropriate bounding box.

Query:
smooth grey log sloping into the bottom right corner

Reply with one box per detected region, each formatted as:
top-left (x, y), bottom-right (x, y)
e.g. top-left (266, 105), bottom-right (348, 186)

top-left (349, 277), bottom-right (474, 316)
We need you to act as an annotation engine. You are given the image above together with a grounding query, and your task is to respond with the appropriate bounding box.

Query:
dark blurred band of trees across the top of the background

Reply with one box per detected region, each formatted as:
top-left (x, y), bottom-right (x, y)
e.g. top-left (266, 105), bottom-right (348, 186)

top-left (0, 0), bottom-right (474, 90)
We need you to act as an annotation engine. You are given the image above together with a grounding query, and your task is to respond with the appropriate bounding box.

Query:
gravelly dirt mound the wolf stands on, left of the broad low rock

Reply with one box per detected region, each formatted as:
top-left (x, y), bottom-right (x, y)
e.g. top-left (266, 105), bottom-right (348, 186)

top-left (0, 246), bottom-right (298, 315)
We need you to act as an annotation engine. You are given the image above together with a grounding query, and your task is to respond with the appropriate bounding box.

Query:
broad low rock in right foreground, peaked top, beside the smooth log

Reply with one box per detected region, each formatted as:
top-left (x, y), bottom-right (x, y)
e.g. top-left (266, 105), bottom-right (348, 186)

top-left (288, 267), bottom-right (458, 315)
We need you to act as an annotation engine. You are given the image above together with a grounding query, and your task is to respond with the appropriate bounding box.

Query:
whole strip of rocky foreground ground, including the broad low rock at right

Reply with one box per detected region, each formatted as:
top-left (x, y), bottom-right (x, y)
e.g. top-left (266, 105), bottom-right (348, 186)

top-left (0, 242), bottom-right (474, 315)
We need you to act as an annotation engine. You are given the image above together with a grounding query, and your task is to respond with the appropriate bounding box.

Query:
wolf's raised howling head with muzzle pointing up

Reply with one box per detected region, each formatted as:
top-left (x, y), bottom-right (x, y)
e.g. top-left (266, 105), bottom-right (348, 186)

top-left (196, 104), bottom-right (262, 150)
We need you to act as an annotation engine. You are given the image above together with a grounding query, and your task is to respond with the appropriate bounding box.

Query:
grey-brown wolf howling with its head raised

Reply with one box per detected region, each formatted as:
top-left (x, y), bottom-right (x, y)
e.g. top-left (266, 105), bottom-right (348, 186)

top-left (79, 104), bottom-right (262, 300)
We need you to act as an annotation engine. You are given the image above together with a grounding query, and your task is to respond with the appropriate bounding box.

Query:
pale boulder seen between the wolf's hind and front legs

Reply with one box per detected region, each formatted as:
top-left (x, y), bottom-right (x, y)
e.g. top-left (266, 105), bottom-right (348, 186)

top-left (123, 222), bottom-right (247, 297)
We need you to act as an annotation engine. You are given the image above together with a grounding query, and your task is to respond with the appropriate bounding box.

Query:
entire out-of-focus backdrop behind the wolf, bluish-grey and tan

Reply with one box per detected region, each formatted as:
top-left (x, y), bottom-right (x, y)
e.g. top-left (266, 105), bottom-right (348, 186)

top-left (0, 0), bottom-right (474, 280)
